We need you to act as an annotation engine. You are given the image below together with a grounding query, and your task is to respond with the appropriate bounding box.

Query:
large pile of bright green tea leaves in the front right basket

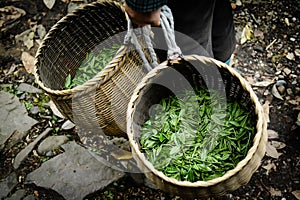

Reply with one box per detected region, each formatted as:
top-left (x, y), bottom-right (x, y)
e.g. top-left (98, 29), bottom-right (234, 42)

top-left (140, 89), bottom-right (255, 182)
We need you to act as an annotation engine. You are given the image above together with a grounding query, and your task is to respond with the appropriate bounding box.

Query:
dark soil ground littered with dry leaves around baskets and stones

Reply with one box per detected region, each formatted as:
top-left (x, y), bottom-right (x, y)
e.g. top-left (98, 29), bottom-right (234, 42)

top-left (0, 0), bottom-right (300, 199)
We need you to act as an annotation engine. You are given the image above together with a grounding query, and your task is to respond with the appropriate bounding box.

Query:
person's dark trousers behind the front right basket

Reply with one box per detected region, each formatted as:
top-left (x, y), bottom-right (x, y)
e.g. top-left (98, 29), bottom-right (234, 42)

top-left (168, 0), bottom-right (236, 62)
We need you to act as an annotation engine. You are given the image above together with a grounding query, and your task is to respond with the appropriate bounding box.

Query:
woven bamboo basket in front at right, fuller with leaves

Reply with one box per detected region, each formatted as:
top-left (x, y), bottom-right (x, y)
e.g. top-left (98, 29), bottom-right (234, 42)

top-left (127, 55), bottom-right (267, 199)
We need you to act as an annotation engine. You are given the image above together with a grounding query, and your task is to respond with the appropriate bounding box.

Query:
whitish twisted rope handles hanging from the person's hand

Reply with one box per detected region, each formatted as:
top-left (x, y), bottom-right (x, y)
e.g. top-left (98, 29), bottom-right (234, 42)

top-left (124, 6), bottom-right (183, 71)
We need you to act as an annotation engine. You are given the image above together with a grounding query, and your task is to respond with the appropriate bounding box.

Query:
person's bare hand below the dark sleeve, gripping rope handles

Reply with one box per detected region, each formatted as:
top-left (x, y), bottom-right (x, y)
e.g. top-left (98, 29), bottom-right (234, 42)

top-left (124, 3), bottom-right (161, 26)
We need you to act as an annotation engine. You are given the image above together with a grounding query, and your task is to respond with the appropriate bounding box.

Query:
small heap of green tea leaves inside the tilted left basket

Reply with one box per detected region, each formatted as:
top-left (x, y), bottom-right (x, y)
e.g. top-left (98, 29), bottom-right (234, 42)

top-left (64, 44), bottom-right (121, 89)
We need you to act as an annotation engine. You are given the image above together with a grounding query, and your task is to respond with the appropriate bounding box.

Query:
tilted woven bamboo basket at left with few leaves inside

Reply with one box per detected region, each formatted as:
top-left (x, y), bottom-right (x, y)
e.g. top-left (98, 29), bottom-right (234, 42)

top-left (34, 0), bottom-right (158, 137)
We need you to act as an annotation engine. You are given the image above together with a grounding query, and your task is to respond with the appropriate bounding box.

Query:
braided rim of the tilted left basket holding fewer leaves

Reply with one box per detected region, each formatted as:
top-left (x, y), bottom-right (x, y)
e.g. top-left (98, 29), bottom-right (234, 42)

top-left (33, 0), bottom-right (128, 96)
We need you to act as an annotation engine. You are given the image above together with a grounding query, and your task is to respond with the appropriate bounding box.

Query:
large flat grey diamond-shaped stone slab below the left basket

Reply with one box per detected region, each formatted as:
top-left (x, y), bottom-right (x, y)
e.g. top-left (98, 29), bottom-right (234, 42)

top-left (26, 141), bottom-right (124, 200)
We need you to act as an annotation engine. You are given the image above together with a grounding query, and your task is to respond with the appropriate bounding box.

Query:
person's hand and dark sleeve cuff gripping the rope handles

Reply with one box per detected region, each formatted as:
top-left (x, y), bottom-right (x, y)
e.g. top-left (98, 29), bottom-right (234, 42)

top-left (124, 0), bottom-right (167, 26)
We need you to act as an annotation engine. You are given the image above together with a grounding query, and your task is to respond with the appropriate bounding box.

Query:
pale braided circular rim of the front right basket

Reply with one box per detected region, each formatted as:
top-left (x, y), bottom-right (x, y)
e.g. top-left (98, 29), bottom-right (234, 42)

top-left (127, 55), bottom-right (267, 187)
